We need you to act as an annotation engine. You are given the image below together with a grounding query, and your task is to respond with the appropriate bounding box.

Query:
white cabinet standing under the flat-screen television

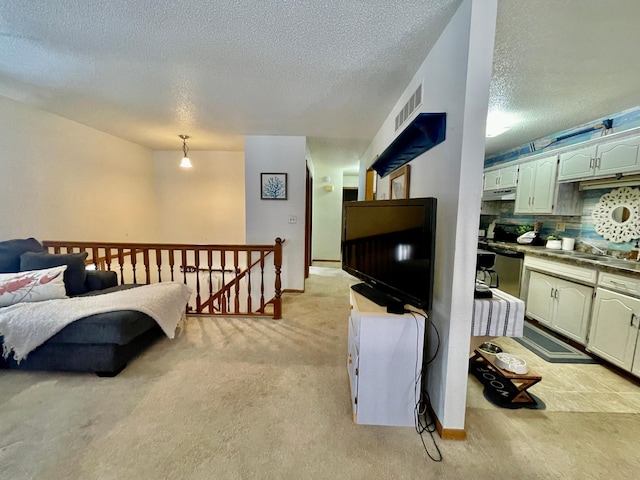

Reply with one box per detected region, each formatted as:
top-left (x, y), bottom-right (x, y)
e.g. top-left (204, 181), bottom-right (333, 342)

top-left (347, 290), bottom-right (425, 427)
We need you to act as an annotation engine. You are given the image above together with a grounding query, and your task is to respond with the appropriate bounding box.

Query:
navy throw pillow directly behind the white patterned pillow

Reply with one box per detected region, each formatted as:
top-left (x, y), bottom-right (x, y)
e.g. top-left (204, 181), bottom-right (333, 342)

top-left (20, 252), bottom-right (87, 296)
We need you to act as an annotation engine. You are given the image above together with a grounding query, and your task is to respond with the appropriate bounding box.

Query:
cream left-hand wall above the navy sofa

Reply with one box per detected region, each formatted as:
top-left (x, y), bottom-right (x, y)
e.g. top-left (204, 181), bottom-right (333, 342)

top-left (0, 97), bottom-right (157, 242)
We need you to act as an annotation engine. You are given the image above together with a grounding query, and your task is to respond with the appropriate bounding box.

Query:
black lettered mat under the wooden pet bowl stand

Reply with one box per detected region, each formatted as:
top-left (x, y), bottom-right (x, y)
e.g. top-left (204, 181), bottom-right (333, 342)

top-left (469, 360), bottom-right (547, 410)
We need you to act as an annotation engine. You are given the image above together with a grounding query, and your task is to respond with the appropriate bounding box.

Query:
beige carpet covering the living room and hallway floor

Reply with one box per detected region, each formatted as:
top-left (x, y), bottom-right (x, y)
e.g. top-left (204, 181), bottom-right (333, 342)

top-left (0, 267), bottom-right (640, 480)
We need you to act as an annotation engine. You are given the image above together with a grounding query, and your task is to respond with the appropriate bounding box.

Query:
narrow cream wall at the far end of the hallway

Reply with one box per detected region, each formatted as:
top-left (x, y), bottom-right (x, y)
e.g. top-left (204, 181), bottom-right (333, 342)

top-left (311, 163), bottom-right (343, 261)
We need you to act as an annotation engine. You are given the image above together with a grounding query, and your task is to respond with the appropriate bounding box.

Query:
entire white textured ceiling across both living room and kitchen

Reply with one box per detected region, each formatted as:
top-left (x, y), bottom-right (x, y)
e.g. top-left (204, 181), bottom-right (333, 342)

top-left (0, 0), bottom-right (640, 171)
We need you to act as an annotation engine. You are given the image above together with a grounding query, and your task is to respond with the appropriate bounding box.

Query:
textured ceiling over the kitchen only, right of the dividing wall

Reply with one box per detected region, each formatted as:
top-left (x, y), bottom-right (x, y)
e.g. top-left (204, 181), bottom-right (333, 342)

top-left (486, 0), bottom-right (640, 155)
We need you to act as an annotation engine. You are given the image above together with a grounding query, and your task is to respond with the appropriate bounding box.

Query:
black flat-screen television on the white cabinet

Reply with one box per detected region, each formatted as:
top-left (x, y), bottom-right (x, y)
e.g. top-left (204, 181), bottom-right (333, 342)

top-left (342, 197), bottom-right (437, 313)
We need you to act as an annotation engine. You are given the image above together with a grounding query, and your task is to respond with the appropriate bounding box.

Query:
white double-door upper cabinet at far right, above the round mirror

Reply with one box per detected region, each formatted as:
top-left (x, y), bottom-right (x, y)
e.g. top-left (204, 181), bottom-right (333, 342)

top-left (558, 135), bottom-right (640, 182)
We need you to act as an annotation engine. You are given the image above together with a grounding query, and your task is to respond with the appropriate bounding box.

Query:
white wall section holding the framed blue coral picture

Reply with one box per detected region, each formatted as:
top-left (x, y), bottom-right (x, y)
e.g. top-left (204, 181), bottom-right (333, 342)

top-left (245, 135), bottom-right (306, 290)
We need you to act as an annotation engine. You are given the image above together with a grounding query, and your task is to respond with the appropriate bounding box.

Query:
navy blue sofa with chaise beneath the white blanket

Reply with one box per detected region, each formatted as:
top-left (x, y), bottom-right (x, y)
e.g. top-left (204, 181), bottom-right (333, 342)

top-left (0, 238), bottom-right (162, 376)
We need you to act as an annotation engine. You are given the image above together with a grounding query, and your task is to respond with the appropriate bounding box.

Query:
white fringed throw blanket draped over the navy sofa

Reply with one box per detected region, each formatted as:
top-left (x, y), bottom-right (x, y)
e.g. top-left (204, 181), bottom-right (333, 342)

top-left (0, 282), bottom-right (191, 362)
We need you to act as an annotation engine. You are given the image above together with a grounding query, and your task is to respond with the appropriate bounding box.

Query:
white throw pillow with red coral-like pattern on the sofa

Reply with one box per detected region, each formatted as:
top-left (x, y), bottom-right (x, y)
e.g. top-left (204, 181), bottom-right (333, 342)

top-left (0, 265), bottom-right (67, 307)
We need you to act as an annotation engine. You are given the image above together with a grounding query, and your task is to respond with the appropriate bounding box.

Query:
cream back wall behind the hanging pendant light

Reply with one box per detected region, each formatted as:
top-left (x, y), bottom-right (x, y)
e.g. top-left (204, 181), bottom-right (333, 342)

top-left (153, 150), bottom-right (245, 244)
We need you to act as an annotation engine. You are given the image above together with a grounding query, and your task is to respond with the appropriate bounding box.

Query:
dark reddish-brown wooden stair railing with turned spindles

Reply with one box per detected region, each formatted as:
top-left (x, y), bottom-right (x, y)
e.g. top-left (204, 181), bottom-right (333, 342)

top-left (42, 238), bottom-right (284, 319)
